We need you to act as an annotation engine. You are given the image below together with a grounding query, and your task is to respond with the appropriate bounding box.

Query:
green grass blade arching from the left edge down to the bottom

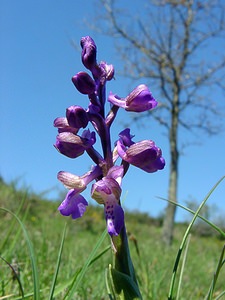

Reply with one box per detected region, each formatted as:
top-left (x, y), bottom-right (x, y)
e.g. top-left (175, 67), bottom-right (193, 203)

top-left (0, 207), bottom-right (40, 300)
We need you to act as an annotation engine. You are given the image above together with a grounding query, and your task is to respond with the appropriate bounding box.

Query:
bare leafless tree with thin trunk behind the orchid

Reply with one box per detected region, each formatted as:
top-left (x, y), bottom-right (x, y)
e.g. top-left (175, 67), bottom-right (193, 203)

top-left (91, 0), bottom-right (225, 245)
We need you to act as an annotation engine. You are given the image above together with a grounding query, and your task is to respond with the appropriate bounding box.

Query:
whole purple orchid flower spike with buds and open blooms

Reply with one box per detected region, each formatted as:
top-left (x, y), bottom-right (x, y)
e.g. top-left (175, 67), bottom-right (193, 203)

top-left (54, 36), bottom-right (165, 237)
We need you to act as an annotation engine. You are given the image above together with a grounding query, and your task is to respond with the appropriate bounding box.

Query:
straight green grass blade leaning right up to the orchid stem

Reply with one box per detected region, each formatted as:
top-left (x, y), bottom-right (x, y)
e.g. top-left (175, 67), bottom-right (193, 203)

top-left (64, 229), bottom-right (107, 300)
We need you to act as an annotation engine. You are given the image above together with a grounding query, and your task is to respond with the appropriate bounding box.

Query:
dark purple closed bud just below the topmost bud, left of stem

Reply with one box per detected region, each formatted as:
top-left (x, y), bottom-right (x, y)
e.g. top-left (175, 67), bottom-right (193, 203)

top-left (72, 72), bottom-right (95, 95)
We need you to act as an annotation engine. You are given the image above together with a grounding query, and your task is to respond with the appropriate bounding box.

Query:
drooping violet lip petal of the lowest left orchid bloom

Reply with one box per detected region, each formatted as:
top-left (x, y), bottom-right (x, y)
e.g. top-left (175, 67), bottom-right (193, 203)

top-left (58, 190), bottom-right (88, 219)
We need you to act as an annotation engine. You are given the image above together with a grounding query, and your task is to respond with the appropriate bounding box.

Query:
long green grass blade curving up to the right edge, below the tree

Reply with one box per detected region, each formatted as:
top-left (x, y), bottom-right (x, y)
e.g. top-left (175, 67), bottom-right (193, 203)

top-left (168, 176), bottom-right (225, 300)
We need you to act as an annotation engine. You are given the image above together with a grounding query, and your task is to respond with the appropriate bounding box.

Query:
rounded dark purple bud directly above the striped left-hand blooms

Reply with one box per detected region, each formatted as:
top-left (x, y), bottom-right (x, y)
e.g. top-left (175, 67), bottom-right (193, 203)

top-left (66, 105), bottom-right (88, 128)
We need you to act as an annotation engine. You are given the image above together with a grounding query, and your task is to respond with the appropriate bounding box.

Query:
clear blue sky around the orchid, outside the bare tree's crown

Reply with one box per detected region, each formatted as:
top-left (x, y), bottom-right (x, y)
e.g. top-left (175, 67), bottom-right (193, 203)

top-left (0, 0), bottom-right (225, 220)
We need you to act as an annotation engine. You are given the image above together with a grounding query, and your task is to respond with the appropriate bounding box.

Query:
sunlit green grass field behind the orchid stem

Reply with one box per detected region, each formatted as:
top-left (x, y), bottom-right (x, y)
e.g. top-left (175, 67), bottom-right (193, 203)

top-left (0, 182), bottom-right (225, 300)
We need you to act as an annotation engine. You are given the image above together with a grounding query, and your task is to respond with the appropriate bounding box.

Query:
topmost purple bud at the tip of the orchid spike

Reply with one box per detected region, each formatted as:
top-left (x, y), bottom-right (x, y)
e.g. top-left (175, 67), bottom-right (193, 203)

top-left (80, 36), bottom-right (97, 70)
